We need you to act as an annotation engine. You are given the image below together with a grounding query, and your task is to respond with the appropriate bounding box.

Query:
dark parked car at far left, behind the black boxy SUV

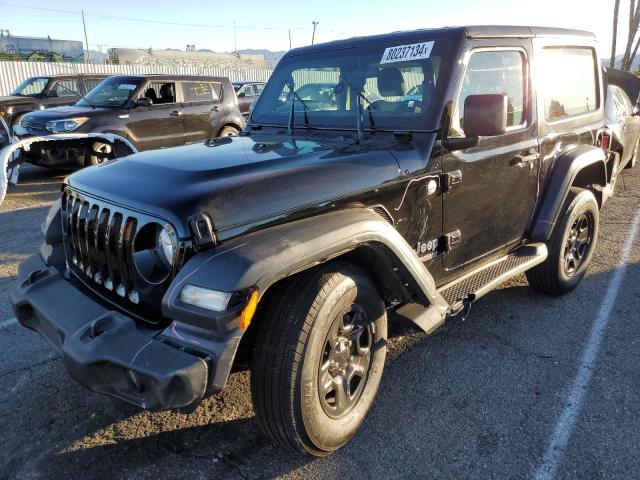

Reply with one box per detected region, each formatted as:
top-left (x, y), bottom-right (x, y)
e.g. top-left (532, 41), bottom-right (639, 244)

top-left (0, 75), bottom-right (107, 126)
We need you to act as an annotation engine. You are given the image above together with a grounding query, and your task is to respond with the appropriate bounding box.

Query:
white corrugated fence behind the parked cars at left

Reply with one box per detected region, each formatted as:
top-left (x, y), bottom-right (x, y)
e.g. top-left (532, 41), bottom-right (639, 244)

top-left (0, 61), bottom-right (272, 96)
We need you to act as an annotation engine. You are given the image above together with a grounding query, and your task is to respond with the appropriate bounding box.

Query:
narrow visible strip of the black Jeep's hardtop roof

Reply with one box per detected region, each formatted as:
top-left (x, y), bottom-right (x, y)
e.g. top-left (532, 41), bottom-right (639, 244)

top-left (289, 25), bottom-right (596, 55)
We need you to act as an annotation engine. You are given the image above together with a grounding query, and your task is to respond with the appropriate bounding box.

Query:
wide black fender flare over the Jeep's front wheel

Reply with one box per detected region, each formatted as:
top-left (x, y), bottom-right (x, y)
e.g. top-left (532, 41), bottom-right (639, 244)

top-left (162, 208), bottom-right (449, 325)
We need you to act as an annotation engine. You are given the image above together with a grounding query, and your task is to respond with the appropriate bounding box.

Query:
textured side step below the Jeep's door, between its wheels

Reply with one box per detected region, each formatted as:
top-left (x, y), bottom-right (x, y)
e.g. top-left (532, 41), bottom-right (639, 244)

top-left (396, 243), bottom-right (548, 333)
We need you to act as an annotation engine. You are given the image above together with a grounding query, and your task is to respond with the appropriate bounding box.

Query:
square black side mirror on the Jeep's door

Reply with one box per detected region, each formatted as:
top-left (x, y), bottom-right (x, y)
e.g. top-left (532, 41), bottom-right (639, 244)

top-left (462, 94), bottom-right (508, 137)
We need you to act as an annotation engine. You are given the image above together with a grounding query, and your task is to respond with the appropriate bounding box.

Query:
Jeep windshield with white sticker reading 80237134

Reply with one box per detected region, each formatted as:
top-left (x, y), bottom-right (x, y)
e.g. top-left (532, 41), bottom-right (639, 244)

top-left (251, 40), bottom-right (450, 130)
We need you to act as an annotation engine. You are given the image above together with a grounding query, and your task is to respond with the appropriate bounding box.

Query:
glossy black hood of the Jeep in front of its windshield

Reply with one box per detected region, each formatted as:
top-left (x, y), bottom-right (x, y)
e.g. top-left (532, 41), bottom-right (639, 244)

top-left (67, 134), bottom-right (406, 238)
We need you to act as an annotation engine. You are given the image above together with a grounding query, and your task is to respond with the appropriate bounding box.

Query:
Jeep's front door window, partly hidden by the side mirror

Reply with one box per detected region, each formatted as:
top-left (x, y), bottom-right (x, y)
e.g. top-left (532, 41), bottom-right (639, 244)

top-left (457, 50), bottom-right (526, 130)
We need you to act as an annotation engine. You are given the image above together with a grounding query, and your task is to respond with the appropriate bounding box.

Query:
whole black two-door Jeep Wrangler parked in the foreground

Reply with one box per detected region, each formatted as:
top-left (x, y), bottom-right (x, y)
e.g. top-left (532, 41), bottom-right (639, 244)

top-left (11, 27), bottom-right (611, 456)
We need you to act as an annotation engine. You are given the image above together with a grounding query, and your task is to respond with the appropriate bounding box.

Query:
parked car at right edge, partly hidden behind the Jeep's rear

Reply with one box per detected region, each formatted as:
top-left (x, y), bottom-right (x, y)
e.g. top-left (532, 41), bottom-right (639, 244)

top-left (604, 85), bottom-right (640, 178)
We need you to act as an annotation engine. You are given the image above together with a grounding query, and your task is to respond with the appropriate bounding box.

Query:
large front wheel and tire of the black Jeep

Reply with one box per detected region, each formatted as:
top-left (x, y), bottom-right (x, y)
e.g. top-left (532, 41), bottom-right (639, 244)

top-left (251, 262), bottom-right (387, 457)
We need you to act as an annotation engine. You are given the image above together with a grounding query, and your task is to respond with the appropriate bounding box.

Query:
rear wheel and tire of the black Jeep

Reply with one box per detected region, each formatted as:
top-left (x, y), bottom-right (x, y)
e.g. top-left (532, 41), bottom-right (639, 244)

top-left (526, 188), bottom-right (600, 296)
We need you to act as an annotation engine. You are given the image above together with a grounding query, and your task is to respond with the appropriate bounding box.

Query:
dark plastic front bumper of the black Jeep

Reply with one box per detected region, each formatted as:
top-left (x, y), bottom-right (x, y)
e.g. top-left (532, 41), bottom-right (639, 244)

top-left (10, 255), bottom-right (231, 409)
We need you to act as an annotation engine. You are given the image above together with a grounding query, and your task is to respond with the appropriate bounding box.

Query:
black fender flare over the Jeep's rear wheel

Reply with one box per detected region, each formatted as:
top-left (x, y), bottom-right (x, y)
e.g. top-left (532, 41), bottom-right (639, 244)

top-left (530, 145), bottom-right (607, 242)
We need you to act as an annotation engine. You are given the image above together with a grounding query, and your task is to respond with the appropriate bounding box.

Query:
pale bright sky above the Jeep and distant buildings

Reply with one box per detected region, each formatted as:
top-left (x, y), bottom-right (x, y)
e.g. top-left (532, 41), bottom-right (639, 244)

top-left (0, 0), bottom-right (629, 57)
